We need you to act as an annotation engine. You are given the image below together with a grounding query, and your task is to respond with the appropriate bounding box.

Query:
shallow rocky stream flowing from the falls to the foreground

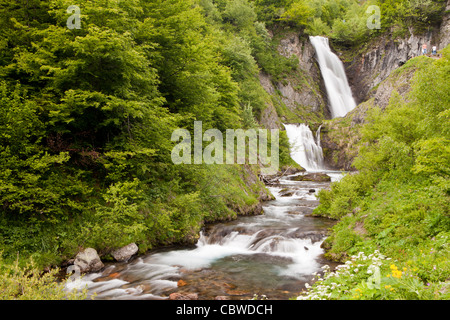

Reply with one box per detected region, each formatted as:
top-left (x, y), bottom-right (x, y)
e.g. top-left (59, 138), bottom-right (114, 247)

top-left (69, 171), bottom-right (341, 300)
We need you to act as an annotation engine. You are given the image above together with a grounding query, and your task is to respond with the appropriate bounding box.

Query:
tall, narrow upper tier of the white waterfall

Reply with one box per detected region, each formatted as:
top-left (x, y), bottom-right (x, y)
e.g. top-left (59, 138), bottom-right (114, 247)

top-left (309, 36), bottom-right (356, 119)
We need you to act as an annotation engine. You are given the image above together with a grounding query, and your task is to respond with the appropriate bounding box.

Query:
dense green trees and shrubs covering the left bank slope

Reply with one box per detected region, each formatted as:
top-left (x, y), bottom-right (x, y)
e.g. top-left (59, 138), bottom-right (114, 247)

top-left (0, 0), bottom-right (296, 282)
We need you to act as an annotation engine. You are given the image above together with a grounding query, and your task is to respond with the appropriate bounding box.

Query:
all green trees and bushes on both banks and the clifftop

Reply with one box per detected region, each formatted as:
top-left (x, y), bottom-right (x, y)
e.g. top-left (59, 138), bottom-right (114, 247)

top-left (0, 0), bottom-right (450, 299)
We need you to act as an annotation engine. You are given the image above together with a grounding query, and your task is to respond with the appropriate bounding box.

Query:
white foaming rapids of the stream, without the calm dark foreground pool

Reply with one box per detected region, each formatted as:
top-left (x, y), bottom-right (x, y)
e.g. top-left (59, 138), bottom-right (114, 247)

top-left (66, 185), bottom-right (330, 300)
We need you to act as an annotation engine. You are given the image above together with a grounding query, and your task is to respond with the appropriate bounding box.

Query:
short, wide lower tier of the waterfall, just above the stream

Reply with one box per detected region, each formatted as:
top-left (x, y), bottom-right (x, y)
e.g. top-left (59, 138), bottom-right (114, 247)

top-left (284, 124), bottom-right (324, 171)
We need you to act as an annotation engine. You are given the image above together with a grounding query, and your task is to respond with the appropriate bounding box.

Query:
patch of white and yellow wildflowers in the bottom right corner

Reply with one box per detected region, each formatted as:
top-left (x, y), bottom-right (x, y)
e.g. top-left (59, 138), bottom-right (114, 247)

top-left (297, 248), bottom-right (449, 300)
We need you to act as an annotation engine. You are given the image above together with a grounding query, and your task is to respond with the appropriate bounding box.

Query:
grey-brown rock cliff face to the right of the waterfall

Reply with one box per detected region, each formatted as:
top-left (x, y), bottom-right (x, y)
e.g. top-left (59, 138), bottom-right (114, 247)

top-left (322, 6), bottom-right (450, 170)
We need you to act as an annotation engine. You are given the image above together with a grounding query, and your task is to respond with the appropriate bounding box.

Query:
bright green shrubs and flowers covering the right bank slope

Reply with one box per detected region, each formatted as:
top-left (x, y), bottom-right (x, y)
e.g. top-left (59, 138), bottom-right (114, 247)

top-left (304, 47), bottom-right (450, 299)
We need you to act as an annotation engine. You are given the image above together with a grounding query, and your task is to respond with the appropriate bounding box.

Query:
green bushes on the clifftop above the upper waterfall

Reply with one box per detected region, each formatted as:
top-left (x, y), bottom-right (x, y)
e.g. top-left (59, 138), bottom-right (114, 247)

top-left (260, 0), bottom-right (446, 47)
